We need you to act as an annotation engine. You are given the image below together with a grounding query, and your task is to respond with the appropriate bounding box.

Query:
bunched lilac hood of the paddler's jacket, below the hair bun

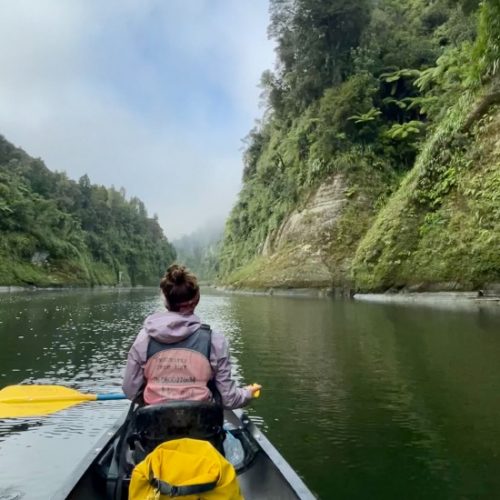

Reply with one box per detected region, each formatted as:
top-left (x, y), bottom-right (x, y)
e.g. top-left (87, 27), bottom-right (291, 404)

top-left (144, 311), bottom-right (201, 344)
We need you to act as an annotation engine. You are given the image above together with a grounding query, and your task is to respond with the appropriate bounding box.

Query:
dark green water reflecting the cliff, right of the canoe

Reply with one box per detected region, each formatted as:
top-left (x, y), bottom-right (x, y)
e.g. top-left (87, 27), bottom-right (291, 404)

top-left (217, 297), bottom-right (500, 498)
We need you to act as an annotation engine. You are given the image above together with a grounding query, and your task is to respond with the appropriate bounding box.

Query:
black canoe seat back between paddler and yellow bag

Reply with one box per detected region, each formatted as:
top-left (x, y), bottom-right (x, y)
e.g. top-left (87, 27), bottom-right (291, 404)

top-left (128, 401), bottom-right (224, 454)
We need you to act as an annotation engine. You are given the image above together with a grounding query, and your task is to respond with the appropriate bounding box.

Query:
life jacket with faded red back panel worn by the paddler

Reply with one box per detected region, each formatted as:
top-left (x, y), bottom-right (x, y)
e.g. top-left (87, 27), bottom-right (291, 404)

top-left (144, 325), bottom-right (213, 404)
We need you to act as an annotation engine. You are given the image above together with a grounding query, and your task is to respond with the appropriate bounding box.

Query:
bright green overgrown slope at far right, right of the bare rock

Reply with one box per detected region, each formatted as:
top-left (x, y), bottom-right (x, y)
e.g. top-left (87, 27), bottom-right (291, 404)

top-left (353, 2), bottom-right (500, 290)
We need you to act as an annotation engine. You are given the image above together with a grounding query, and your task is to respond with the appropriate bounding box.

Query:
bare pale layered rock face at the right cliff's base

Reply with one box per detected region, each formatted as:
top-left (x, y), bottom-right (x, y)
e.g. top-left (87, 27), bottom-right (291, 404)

top-left (225, 162), bottom-right (394, 293)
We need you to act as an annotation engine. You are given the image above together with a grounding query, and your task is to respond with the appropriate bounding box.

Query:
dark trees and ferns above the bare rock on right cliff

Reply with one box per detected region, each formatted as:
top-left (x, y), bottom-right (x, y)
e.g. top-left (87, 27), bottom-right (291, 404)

top-left (220, 0), bottom-right (500, 287)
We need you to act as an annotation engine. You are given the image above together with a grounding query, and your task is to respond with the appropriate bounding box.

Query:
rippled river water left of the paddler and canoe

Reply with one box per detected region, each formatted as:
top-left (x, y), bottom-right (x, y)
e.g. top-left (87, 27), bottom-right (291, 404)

top-left (0, 292), bottom-right (157, 499)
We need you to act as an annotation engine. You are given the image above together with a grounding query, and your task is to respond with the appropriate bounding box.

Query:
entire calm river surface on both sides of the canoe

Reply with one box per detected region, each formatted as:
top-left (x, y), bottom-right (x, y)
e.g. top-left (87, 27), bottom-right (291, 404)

top-left (0, 289), bottom-right (500, 500)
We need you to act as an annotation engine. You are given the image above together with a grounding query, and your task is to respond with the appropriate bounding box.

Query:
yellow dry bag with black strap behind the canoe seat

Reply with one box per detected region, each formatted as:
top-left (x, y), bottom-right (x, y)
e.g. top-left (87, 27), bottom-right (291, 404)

top-left (128, 438), bottom-right (243, 500)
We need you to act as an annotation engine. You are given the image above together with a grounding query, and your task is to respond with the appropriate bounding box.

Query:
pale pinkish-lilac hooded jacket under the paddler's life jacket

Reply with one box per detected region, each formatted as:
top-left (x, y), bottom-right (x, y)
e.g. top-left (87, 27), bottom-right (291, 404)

top-left (123, 311), bottom-right (252, 409)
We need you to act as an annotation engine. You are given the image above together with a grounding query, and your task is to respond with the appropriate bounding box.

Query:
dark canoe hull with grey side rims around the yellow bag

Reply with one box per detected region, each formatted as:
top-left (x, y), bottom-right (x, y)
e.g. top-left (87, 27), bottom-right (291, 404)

top-left (57, 404), bottom-right (316, 500)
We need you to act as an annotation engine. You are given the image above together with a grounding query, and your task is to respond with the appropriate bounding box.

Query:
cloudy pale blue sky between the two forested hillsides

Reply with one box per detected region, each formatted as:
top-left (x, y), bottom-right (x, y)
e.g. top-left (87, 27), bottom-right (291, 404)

top-left (0, 0), bottom-right (274, 240)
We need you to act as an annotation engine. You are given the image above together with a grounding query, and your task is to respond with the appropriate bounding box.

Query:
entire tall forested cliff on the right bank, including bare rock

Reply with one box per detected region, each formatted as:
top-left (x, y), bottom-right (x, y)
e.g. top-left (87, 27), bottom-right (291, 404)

top-left (219, 0), bottom-right (500, 291)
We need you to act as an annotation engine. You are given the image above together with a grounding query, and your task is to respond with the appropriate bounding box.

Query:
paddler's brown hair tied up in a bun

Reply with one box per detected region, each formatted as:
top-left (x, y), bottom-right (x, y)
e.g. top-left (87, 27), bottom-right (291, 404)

top-left (160, 264), bottom-right (200, 312)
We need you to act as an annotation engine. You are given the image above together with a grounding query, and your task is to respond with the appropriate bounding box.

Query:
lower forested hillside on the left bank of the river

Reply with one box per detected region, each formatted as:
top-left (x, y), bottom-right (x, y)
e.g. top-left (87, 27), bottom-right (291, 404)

top-left (0, 136), bottom-right (175, 286)
